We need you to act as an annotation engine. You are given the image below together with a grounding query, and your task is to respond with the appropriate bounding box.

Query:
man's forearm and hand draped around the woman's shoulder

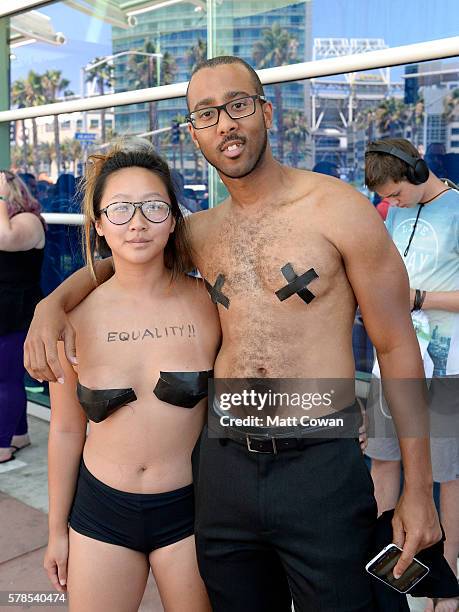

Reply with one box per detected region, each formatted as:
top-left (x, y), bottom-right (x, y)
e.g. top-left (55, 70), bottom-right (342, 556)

top-left (24, 257), bottom-right (113, 382)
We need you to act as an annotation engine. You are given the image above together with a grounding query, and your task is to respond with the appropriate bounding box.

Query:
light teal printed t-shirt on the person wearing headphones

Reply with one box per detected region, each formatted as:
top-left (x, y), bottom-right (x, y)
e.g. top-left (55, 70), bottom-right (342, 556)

top-left (386, 189), bottom-right (459, 376)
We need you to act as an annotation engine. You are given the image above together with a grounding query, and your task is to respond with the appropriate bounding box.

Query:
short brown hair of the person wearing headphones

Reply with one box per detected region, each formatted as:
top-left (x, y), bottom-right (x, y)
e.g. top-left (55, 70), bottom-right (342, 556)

top-left (365, 138), bottom-right (420, 190)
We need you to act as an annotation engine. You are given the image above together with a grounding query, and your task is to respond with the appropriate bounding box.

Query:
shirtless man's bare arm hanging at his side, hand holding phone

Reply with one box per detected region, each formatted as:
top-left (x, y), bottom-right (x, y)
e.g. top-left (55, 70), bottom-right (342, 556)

top-left (329, 186), bottom-right (441, 575)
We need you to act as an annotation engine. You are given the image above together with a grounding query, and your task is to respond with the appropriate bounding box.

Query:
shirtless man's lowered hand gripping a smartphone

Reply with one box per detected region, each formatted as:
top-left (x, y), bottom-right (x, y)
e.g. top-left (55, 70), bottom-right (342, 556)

top-left (392, 483), bottom-right (442, 578)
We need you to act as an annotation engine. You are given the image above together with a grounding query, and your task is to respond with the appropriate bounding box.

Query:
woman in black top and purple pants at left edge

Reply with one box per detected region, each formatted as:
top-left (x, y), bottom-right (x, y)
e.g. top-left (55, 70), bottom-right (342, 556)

top-left (0, 170), bottom-right (45, 464)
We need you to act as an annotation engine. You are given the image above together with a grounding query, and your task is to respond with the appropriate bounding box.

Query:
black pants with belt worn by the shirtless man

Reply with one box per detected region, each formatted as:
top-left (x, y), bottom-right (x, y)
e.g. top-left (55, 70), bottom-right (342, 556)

top-left (195, 430), bottom-right (376, 612)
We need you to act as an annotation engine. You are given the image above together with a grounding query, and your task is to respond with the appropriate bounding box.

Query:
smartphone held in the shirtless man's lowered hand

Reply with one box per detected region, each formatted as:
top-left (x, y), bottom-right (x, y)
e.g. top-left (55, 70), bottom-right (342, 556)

top-left (365, 544), bottom-right (429, 593)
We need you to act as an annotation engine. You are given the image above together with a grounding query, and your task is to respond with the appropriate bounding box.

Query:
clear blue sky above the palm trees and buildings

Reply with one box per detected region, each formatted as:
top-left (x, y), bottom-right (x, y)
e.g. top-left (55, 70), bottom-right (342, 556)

top-left (11, 0), bottom-right (459, 93)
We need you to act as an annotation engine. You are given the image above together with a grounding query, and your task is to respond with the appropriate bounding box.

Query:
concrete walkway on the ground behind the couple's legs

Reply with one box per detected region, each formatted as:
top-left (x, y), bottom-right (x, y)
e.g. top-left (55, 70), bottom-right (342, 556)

top-left (0, 405), bottom-right (434, 612)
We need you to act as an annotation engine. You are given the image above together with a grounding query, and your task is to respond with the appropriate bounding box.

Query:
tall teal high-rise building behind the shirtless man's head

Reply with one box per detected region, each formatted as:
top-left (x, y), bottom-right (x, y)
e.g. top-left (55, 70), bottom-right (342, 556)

top-left (112, 0), bottom-right (312, 176)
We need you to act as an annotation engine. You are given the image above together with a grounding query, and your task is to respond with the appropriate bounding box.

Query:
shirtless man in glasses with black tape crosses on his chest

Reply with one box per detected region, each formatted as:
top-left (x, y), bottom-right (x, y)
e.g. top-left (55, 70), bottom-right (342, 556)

top-left (25, 57), bottom-right (441, 612)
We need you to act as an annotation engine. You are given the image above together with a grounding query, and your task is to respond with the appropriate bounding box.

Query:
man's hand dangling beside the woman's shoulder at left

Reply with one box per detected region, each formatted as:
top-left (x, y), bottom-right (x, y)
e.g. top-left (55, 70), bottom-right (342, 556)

top-left (24, 299), bottom-right (77, 383)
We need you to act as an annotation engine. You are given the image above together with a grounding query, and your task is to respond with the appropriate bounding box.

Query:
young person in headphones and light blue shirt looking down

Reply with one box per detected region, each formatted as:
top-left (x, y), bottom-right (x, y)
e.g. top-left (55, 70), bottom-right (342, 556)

top-left (365, 138), bottom-right (459, 612)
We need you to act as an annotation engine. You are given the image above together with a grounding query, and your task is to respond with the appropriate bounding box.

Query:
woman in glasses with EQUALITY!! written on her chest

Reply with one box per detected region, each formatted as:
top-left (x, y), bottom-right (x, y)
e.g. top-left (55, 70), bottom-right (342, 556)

top-left (45, 145), bottom-right (220, 612)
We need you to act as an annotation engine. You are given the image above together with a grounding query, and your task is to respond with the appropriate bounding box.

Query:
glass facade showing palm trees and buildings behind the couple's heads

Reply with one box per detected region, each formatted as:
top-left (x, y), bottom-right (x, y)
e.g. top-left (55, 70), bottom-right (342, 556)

top-left (4, 0), bottom-right (459, 184)
